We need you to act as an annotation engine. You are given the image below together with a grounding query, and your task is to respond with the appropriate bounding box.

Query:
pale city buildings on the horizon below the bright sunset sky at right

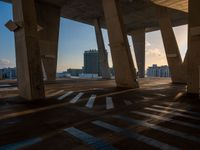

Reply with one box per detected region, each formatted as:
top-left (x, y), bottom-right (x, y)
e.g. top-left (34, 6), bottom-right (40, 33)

top-left (147, 64), bottom-right (171, 77)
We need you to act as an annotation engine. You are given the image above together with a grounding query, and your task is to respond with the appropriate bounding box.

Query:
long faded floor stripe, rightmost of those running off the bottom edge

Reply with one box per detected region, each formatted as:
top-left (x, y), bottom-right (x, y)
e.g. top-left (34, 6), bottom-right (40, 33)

top-left (92, 120), bottom-right (179, 150)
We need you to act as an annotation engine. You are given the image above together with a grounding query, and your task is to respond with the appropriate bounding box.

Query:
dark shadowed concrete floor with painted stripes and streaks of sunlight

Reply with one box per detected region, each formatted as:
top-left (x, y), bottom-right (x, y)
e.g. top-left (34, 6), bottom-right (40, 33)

top-left (0, 78), bottom-right (200, 150)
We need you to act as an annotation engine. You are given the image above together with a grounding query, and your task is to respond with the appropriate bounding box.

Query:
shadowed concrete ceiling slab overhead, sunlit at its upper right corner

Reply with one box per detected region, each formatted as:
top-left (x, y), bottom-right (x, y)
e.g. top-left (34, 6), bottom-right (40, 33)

top-left (1, 0), bottom-right (188, 33)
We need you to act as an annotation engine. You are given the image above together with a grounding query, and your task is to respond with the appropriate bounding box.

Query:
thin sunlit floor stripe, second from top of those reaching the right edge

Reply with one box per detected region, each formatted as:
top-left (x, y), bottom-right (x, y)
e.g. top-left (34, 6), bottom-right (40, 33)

top-left (144, 107), bottom-right (200, 120)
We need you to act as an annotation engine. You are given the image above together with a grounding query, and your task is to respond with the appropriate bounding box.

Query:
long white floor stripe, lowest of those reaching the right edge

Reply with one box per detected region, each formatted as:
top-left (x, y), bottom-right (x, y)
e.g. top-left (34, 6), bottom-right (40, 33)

top-left (113, 115), bottom-right (200, 143)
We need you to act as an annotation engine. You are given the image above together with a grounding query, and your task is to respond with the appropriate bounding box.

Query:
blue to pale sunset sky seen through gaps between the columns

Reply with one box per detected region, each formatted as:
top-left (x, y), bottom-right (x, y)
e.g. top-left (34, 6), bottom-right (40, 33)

top-left (0, 1), bottom-right (187, 72)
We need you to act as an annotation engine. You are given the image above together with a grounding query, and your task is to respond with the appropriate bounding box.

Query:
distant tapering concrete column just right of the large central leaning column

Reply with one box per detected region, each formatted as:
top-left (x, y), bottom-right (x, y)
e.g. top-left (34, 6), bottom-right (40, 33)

top-left (132, 29), bottom-right (145, 78)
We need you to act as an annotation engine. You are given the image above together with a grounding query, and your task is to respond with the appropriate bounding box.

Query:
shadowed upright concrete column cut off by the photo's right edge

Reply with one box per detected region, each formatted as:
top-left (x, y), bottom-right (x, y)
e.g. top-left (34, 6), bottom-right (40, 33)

top-left (187, 0), bottom-right (200, 94)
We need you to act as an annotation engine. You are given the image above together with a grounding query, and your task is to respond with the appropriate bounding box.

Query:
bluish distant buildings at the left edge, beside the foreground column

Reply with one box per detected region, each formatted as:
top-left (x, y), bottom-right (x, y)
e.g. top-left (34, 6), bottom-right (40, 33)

top-left (0, 68), bottom-right (17, 80)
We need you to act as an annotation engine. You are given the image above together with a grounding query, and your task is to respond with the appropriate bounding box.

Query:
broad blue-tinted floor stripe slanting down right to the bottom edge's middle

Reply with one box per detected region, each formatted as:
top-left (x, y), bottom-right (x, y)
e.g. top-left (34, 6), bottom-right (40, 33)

top-left (64, 127), bottom-right (117, 150)
